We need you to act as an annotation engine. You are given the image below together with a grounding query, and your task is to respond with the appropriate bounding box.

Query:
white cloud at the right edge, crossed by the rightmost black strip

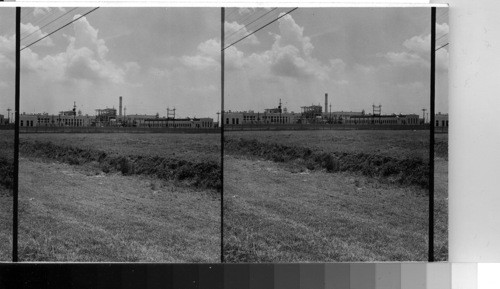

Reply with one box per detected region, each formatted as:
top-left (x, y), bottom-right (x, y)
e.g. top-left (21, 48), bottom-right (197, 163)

top-left (385, 23), bottom-right (449, 70)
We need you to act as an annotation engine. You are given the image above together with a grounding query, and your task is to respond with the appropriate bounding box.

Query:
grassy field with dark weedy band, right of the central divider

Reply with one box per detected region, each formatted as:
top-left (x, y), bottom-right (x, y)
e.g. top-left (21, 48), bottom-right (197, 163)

top-left (224, 131), bottom-right (447, 262)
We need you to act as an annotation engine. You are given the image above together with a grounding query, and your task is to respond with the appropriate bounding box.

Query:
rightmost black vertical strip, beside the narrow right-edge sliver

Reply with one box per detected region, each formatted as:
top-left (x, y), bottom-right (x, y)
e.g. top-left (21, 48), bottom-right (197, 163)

top-left (429, 7), bottom-right (436, 262)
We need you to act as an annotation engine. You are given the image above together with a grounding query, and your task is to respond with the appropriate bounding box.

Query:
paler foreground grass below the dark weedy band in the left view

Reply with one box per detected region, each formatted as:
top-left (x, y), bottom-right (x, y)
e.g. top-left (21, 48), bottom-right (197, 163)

top-left (19, 159), bottom-right (220, 262)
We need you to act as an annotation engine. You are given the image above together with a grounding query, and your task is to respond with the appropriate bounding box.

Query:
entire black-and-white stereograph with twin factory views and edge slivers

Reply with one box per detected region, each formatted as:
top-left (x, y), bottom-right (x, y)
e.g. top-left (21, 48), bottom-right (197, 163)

top-left (0, 3), bottom-right (450, 263)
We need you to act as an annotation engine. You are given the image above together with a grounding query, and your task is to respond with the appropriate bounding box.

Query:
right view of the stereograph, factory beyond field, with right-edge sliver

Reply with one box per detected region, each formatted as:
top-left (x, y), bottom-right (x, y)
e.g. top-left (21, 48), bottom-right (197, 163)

top-left (222, 8), bottom-right (449, 262)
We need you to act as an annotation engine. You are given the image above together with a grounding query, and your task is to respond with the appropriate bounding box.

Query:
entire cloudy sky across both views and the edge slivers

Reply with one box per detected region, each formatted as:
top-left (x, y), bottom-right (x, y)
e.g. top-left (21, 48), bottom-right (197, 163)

top-left (0, 8), bottom-right (449, 119)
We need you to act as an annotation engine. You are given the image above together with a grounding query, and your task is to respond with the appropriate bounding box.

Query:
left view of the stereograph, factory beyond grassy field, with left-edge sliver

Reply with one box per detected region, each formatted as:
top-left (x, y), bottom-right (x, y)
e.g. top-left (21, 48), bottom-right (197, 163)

top-left (0, 7), bottom-right (221, 262)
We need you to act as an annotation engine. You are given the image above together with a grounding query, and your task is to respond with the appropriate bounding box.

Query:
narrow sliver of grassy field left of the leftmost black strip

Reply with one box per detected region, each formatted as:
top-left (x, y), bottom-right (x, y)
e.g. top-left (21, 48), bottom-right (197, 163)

top-left (0, 130), bottom-right (14, 261)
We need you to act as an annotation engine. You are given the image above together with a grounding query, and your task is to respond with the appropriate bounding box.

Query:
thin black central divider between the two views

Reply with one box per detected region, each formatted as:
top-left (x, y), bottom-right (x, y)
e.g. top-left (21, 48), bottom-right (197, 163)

top-left (220, 7), bottom-right (226, 263)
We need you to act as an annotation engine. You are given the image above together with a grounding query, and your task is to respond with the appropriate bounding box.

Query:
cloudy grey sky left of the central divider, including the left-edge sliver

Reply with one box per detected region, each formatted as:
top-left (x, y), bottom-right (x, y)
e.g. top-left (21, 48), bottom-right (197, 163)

top-left (0, 8), bottom-right (221, 119)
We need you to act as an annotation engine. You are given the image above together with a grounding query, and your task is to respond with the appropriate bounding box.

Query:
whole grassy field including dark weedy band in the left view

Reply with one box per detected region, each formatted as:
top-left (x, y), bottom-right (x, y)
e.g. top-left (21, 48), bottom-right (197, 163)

top-left (19, 133), bottom-right (221, 262)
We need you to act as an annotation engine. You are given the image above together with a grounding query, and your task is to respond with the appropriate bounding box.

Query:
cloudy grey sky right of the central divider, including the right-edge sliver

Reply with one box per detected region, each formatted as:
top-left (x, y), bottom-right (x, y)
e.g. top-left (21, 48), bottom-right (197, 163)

top-left (225, 8), bottom-right (449, 115)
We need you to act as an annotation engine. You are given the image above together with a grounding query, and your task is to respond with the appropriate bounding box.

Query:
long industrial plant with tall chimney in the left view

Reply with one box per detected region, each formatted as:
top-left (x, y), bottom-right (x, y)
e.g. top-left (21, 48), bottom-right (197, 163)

top-left (19, 96), bottom-right (218, 128)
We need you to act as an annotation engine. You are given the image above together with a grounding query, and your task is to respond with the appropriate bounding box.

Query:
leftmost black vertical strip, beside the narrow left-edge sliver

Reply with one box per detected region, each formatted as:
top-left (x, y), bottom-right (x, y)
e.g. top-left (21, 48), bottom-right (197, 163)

top-left (12, 7), bottom-right (21, 262)
